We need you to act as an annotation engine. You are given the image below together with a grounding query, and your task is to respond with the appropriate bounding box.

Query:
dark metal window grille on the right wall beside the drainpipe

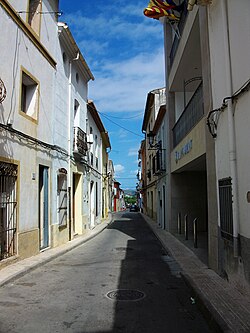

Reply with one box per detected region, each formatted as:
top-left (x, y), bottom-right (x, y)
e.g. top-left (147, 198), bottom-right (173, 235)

top-left (219, 177), bottom-right (233, 240)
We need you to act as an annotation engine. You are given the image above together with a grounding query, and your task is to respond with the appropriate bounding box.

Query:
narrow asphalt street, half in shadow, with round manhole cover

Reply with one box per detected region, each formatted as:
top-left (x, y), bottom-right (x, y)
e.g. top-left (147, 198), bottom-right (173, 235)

top-left (0, 211), bottom-right (213, 333)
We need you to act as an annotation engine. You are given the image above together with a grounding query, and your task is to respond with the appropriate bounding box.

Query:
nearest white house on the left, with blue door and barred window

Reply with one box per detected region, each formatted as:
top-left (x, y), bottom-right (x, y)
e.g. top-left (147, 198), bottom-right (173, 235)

top-left (0, 1), bottom-right (59, 259)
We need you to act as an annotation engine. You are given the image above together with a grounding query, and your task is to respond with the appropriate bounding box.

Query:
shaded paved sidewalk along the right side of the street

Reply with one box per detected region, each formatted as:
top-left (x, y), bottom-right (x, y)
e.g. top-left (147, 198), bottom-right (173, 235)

top-left (141, 214), bottom-right (250, 333)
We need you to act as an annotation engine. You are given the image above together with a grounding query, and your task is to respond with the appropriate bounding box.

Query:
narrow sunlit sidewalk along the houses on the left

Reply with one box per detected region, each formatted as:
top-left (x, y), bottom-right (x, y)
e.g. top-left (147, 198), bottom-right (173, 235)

top-left (0, 218), bottom-right (112, 287)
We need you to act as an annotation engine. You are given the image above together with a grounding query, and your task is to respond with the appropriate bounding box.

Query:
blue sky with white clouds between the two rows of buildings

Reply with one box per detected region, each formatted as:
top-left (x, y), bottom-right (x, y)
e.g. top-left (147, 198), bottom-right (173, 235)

top-left (60, 0), bottom-right (165, 189)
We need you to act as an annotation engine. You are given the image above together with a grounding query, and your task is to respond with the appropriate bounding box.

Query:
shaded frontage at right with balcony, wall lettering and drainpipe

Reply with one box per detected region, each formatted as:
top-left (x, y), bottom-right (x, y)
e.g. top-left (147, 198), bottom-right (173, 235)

top-left (148, 0), bottom-right (250, 292)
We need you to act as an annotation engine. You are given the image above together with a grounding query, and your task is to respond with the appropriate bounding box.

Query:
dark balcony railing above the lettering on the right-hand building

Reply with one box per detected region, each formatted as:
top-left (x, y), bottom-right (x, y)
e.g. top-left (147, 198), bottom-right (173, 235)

top-left (173, 83), bottom-right (204, 147)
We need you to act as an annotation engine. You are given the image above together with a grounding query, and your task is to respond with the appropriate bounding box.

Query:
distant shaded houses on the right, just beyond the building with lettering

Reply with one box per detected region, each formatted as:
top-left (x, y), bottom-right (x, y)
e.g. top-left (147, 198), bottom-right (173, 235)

top-left (141, 88), bottom-right (167, 223)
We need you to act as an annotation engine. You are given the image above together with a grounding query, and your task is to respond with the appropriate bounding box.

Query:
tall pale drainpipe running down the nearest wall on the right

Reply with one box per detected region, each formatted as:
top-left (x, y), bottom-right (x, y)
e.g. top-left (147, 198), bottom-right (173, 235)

top-left (221, 0), bottom-right (239, 257)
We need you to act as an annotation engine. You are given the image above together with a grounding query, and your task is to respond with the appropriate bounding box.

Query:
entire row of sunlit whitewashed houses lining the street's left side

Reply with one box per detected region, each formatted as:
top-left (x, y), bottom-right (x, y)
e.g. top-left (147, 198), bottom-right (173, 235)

top-left (0, 0), bottom-right (110, 264)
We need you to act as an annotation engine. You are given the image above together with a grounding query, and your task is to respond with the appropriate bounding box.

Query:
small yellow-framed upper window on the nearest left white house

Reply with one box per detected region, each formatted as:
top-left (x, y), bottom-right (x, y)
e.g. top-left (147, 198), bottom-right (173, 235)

top-left (20, 70), bottom-right (39, 119)
